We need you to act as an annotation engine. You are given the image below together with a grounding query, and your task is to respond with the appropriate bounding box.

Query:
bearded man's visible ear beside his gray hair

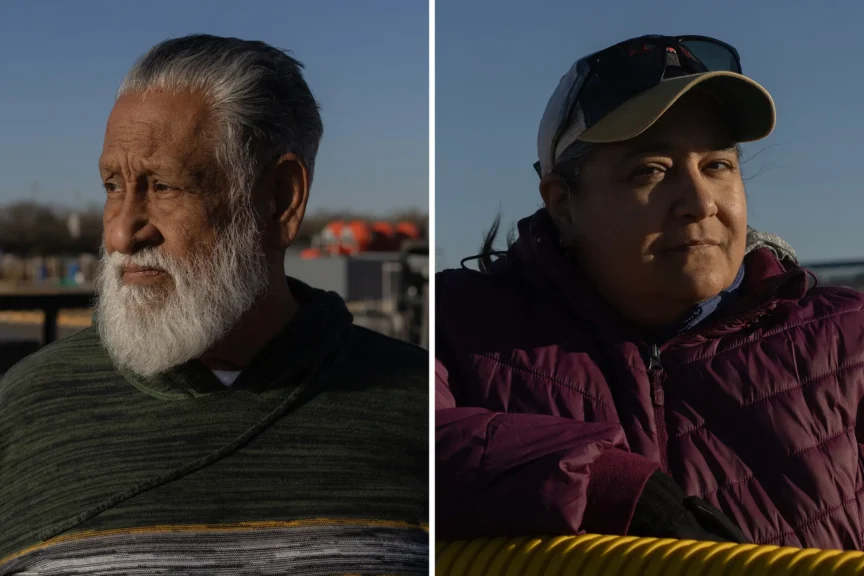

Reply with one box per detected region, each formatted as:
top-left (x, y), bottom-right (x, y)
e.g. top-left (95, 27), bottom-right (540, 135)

top-left (272, 154), bottom-right (309, 250)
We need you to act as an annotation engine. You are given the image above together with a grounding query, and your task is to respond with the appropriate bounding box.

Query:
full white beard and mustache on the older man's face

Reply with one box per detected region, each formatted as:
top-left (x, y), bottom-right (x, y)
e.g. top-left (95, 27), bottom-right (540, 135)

top-left (96, 207), bottom-right (267, 376)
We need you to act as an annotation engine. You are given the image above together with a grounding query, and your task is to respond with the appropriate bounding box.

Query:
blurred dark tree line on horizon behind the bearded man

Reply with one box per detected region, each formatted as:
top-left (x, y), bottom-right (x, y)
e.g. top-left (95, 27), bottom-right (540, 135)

top-left (0, 201), bottom-right (429, 256)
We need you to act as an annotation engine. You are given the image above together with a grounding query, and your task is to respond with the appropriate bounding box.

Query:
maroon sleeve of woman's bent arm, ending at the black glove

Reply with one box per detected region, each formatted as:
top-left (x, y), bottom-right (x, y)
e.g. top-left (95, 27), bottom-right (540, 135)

top-left (435, 360), bottom-right (657, 540)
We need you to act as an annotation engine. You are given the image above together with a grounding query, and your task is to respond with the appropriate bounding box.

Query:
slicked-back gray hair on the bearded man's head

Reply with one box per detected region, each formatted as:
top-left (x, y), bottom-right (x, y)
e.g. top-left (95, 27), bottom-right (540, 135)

top-left (117, 34), bottom-right (324, 198)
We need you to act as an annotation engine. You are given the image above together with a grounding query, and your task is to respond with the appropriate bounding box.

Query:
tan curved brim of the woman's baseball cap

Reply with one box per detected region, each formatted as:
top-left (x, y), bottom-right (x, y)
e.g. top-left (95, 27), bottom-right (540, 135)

top-left (578, 72), bottom-right (777, 144)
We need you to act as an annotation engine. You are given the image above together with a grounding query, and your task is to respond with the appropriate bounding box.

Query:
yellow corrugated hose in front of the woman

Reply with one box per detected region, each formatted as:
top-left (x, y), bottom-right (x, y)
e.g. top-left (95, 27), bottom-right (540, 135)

top-left (435, 534), bottom-right (864, 576)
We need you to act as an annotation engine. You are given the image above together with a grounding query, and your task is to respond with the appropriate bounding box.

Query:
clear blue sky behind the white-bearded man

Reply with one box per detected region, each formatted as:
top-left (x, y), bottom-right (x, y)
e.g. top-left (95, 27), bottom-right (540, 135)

top-left (0, 0), bottom-right (429, 214)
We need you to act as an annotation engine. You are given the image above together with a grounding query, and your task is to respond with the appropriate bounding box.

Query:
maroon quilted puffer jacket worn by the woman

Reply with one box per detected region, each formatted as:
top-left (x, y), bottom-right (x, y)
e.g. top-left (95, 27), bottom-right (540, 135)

top-left (436, 211), bottom-right (864, 550)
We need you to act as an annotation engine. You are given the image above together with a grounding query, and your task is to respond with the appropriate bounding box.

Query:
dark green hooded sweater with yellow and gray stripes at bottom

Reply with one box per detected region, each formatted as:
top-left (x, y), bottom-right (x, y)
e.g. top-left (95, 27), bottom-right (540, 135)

top-left (0, 281), bottom-right (429, 575)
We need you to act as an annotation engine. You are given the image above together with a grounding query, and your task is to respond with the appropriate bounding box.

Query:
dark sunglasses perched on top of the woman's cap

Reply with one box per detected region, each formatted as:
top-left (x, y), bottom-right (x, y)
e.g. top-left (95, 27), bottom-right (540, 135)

top-left (534, 35), bottom-right (742, 175)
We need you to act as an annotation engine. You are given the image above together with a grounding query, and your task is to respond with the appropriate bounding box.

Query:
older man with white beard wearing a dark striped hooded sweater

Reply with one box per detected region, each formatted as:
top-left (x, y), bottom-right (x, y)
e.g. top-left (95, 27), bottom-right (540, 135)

top-left (0, 35), bottom-right (428, 574)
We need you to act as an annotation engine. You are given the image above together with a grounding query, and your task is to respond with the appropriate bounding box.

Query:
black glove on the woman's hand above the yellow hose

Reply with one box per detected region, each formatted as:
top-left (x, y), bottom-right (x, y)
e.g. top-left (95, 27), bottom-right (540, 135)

top-left (627, 470), bottom-right (748, 544)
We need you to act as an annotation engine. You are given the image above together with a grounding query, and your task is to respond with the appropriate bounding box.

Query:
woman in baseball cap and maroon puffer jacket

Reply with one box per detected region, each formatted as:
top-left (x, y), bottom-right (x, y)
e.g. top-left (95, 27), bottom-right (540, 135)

top-left (436, 36), bottom-right (864, 549)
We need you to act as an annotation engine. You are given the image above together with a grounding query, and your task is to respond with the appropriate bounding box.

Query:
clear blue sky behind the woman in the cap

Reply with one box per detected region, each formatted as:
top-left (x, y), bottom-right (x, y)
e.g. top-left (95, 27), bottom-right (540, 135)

top-left (435, 0), bottom-right (864, 269)
